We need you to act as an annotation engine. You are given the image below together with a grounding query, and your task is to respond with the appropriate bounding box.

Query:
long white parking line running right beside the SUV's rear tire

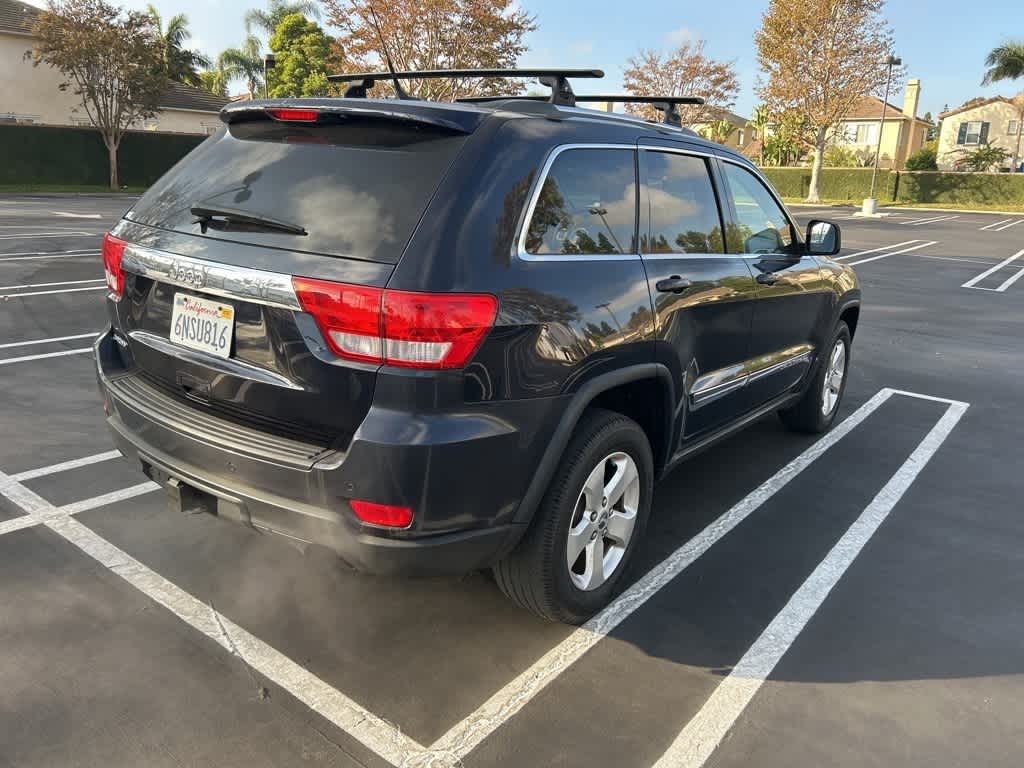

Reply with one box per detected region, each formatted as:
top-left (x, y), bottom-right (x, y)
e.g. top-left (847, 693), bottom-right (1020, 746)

top-left (423, 389), bottom-right (895, 758)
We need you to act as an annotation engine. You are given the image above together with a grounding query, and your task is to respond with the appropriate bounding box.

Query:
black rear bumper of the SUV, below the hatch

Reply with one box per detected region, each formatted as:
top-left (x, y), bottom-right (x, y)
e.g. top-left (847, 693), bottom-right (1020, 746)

top-left (95, 330), bottom-right (561, 574)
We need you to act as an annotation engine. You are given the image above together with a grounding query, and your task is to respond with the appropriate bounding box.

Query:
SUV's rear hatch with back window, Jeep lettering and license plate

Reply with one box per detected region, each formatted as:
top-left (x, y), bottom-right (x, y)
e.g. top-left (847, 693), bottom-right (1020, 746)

top-left (113, 99), bottom-right (480, 449)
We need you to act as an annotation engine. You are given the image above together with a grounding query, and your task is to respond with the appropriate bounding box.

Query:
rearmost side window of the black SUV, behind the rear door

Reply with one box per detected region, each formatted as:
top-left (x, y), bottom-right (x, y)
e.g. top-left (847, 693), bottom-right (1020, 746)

top-left (525, 148), bottom-right (637, 256)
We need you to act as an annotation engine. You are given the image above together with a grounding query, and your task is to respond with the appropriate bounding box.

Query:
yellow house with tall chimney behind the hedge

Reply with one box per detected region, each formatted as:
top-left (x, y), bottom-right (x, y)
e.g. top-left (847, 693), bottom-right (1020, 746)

top-left (829, 79), bottom-right (930, 170)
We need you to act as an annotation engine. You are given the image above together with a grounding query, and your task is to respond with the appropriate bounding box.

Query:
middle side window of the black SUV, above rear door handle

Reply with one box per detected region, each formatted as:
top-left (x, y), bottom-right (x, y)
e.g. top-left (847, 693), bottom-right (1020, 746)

top-left (640, 150), bottom-right (724, 254)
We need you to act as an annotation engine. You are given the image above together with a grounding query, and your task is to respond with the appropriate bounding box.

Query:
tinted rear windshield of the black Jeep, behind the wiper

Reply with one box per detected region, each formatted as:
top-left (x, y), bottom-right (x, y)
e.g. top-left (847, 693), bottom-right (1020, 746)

top-left (127, 119), bottom-right (466, 263)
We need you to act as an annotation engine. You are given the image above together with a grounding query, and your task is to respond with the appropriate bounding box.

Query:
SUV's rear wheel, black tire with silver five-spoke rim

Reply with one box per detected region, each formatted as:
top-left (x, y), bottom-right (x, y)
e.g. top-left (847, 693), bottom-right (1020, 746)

top-left (494, 409), bottom-right (654, 624)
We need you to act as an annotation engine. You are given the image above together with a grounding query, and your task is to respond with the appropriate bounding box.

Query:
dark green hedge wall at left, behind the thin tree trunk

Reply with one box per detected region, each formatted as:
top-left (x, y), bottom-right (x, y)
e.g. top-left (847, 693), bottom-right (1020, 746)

top-left (0, 125), bottom-right (205, 186)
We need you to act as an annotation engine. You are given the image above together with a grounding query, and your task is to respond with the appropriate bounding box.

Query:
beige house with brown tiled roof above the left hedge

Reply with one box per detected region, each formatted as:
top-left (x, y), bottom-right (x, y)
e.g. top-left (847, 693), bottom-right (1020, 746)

top-left (0, 0), bottom-right (227, 133)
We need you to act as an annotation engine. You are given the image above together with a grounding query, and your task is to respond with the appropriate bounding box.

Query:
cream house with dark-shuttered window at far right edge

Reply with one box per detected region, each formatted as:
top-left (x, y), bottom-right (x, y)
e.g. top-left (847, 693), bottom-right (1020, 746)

top-left (937, 96), bottom-right (1024, 171)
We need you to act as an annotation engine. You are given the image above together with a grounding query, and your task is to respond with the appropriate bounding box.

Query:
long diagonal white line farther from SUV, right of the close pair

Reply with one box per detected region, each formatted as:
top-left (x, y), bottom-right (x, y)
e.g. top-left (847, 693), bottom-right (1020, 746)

top-left (654, 402), bottom-right (968, 768)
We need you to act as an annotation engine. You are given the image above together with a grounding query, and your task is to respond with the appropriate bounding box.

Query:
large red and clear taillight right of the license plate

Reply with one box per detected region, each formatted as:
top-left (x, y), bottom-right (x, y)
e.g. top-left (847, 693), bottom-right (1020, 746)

top-left (292, 278), bottom-right (498, 369)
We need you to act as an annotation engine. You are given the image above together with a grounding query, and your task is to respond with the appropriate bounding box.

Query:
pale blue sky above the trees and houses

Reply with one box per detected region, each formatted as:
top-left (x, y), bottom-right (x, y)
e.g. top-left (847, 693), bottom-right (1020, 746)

top-left (29, 0), bottom-right (1024, 117)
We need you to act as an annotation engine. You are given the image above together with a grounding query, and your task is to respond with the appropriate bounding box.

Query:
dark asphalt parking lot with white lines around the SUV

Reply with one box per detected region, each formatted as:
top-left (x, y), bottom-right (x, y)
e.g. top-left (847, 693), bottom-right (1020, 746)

top-left (0, 196), bottom-right (1024, 768)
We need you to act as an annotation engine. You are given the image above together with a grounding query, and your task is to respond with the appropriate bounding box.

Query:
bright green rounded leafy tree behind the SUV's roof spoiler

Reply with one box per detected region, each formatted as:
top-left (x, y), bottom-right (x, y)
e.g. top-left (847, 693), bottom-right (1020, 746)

top-left (267, 13), bottom-right (336, 98)
